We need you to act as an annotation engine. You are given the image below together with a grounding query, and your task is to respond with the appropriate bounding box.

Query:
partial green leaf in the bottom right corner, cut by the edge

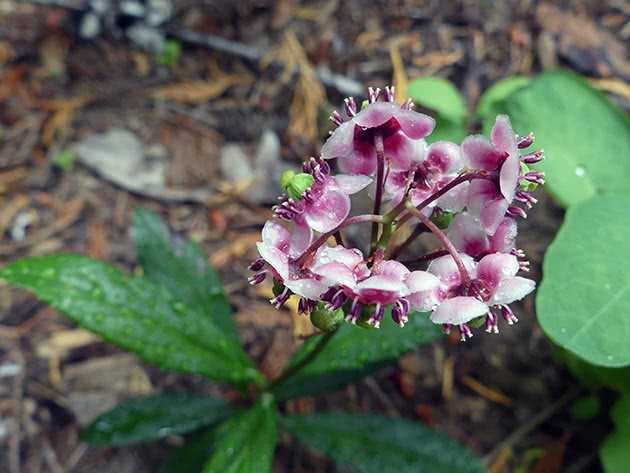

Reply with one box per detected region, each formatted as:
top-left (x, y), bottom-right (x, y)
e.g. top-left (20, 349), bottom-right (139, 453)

top-left (599, 396), bottom-right (630, 473)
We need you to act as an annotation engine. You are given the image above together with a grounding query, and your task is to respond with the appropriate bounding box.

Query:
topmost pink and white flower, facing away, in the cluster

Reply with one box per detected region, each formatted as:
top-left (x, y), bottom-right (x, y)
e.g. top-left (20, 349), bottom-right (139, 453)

top-left (321, 87), bottom-right (435, 176)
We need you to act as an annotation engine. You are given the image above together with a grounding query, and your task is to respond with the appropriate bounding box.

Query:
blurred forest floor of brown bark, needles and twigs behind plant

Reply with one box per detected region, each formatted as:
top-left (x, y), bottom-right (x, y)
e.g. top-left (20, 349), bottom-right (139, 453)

top-left (0, 0), bottom-right (630, 473)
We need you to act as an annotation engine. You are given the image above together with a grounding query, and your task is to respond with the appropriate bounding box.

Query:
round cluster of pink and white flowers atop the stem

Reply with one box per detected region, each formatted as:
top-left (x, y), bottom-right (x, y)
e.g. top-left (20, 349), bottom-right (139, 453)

top-left (250, 87), bottom-right (544, 340)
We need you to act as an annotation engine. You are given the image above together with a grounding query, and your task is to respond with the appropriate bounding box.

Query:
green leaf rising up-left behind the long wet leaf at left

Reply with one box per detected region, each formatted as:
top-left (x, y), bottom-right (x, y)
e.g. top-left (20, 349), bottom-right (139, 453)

top-left (131, 209), bottom-right (238, 340)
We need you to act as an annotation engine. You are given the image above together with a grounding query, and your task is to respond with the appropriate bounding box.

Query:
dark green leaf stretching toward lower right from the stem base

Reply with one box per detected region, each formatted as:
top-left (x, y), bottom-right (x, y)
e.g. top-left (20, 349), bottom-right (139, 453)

top-left (281, 413), bottom-right (486, 473)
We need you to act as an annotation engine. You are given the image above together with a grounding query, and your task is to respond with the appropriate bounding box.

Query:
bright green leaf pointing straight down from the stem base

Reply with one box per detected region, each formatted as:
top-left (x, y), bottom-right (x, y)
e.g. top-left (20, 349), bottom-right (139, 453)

top-left (203, 399), bottom-right (277, 473)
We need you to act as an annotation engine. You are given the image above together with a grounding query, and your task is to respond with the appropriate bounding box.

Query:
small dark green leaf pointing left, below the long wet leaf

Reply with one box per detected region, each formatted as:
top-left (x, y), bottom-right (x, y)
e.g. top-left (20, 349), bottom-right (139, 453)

top-left (81, 394), bottom-right (229, 445)
